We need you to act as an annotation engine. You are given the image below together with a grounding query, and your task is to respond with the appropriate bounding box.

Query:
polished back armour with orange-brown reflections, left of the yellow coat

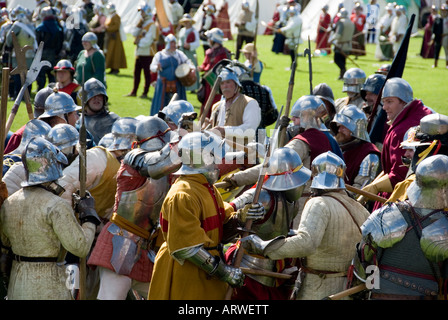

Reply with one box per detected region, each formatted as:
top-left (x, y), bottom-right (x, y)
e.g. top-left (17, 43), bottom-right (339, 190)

top-left (117, 176), bottom-right (170, 231)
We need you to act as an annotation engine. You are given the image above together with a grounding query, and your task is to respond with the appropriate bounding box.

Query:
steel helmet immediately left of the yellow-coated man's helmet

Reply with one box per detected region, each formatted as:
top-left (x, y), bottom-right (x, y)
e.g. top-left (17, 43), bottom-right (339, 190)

top-left (132, 116), bottom-right (179, 152)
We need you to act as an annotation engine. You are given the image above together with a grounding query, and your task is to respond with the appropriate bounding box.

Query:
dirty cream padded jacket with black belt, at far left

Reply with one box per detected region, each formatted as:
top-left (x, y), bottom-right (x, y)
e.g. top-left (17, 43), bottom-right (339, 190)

top-left (0, 187), bottom-right (95, 300)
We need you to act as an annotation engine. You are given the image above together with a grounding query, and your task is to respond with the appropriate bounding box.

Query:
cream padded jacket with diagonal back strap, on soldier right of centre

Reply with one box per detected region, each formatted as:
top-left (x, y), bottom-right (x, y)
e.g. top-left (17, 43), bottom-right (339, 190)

top-left (266, 191), bottom-right (369, 300)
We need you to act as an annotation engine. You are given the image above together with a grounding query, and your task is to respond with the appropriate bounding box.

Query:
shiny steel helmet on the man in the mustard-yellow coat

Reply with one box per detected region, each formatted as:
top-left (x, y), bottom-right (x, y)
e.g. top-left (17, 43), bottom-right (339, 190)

top-left (176, 131), bottom-right (228, 179)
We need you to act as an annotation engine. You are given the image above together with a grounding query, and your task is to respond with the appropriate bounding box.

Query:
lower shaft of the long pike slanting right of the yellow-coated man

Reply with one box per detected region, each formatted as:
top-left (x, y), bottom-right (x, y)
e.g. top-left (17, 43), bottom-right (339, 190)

top-left (226, 113), bottom-right (281, 300)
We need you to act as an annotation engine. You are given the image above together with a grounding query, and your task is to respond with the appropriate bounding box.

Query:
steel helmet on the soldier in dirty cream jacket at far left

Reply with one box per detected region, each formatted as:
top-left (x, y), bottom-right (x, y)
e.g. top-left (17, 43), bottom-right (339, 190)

top-left (21, 137), bottom-right (67, 187)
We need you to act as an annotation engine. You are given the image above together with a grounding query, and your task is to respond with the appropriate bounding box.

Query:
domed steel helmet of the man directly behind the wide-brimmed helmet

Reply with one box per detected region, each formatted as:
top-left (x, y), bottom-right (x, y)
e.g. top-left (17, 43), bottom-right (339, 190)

top-left (291, 95), bottom-right (325, 130)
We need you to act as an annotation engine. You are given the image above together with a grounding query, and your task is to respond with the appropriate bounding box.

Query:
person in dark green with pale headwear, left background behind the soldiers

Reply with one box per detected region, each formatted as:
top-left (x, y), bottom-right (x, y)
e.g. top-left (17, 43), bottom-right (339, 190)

top-left (75, 32), bottom-right (106, 84)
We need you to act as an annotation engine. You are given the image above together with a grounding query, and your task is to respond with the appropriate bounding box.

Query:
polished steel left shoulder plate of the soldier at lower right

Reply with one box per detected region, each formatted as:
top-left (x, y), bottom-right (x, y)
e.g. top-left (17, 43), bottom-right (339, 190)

top-left (361, 203), bottom-right (408, 248)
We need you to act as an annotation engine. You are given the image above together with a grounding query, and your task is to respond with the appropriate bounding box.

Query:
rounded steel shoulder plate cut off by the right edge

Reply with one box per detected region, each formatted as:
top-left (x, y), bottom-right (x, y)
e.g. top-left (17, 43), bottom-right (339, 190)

top-left (420, 213), bottom-right (448, 262)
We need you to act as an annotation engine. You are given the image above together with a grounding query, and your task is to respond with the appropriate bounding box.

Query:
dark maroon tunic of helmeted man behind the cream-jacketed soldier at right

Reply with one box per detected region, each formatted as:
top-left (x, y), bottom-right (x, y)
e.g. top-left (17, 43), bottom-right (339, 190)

top-left (344, 141), bottom-right (381, 185)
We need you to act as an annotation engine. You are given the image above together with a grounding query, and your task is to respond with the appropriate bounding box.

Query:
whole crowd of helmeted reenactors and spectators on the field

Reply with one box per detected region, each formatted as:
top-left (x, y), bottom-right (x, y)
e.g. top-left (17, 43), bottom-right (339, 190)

top-left (0, 0), bottom-right (448, 301)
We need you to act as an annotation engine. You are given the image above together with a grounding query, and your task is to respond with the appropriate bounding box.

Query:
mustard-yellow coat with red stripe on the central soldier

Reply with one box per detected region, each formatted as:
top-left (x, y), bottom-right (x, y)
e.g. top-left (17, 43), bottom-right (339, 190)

top-left (148, 174), bottom-right (233, 300)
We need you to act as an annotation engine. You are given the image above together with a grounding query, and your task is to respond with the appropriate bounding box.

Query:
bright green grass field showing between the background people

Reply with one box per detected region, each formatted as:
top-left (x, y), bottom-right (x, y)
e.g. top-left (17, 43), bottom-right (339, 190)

top-left (4, 31), bottom-right (448, 131)
